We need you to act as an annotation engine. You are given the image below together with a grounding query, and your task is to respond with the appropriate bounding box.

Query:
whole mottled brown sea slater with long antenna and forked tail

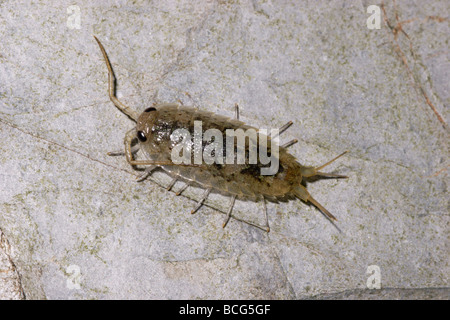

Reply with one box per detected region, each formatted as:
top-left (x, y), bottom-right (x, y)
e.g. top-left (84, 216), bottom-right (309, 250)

top-left (94, 36), bottom-right (347, 231)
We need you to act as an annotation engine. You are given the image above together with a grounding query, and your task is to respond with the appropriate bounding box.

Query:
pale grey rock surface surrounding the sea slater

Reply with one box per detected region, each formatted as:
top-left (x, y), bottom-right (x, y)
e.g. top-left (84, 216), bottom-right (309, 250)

top-left (0, 0), bottom-right (450, 299)
